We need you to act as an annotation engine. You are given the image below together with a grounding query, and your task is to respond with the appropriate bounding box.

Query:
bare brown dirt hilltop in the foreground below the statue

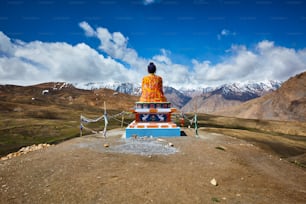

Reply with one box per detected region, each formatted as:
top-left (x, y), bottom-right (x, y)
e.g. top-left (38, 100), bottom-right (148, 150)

top-left (0, 130), bottom-right (306, 204)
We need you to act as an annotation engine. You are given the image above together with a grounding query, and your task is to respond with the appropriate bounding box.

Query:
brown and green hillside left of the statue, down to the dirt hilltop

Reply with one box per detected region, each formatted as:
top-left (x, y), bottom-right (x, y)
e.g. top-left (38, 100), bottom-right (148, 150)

top-left (0, 83), bottom-right (138, 155)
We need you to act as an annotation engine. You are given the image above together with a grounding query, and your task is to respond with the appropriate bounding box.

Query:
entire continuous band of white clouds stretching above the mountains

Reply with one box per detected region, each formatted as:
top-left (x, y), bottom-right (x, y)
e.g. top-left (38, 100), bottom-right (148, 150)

top-left (0, 22), bottom-right (306, 88)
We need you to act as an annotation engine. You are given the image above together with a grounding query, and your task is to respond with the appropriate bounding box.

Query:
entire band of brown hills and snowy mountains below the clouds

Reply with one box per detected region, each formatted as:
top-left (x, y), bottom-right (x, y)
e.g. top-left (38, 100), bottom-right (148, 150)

top-left (0, 72), bottom-right (306, 121)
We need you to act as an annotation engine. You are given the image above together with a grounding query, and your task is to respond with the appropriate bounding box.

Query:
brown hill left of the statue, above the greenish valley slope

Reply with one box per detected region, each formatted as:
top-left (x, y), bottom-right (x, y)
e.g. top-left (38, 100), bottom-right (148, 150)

top-left (0, 82), bottom-right (138, 111)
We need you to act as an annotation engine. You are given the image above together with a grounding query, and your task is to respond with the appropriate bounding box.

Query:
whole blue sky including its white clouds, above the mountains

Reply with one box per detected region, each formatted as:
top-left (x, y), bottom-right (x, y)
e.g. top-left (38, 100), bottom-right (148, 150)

top-left (0, 0), bottom-right (306, 87)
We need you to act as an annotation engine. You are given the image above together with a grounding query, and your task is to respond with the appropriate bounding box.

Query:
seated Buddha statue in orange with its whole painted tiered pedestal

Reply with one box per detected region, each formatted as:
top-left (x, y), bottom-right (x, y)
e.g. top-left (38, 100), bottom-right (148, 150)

top-left (125, 62), bottom-right (181, 138)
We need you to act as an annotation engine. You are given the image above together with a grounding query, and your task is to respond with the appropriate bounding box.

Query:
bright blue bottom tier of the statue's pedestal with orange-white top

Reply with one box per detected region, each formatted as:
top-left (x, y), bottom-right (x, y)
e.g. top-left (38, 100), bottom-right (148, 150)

top-left (125, 121), bottom-right (181, 138)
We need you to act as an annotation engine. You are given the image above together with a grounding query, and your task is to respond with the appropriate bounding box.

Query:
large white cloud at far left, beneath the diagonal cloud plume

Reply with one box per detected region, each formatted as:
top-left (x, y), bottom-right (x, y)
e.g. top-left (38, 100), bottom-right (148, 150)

top-left (0, 31), bottom-right (130, 84)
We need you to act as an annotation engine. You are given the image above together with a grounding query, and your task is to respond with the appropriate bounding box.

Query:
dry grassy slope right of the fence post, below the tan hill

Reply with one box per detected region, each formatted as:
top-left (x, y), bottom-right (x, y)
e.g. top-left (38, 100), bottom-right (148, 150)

top-left (183, 114), bottom-right (306, 167)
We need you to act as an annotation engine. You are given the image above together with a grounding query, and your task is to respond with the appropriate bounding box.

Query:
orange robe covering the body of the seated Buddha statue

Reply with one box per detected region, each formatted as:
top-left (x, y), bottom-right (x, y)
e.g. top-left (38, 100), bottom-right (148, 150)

top-left (140, 74), bottom-right (167, 102)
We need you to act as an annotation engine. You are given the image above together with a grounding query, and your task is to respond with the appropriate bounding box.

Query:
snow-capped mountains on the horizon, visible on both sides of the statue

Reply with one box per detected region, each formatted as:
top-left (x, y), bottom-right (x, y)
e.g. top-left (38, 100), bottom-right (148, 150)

top-left (73, 81), bottom-right (281, 111)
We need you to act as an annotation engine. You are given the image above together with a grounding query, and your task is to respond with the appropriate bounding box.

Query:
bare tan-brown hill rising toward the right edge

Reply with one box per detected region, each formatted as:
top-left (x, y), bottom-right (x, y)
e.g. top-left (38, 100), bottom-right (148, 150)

top-left (214, 72), bottom-right (306, 121)
